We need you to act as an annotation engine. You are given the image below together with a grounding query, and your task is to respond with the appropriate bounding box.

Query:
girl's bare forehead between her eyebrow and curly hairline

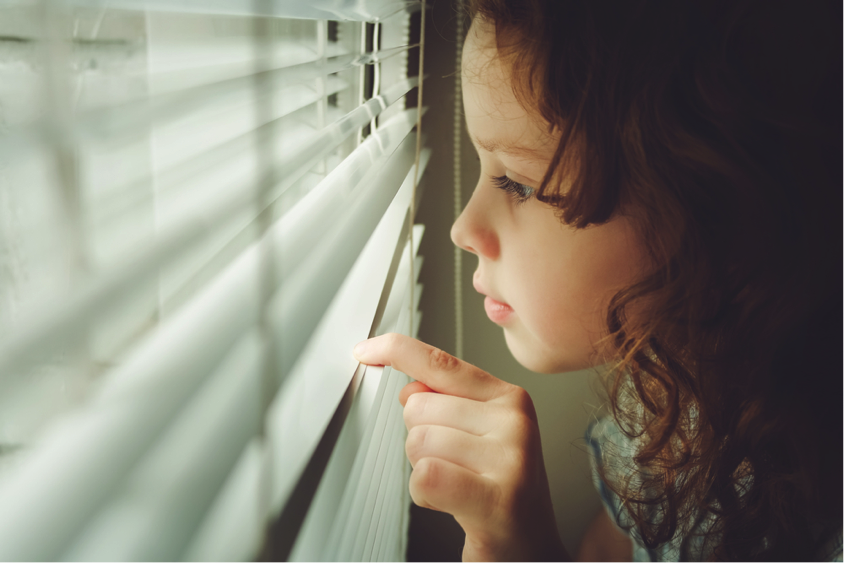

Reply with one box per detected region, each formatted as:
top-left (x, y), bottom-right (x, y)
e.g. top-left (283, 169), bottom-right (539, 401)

top-left (462, 19), bottom-right (556, 158)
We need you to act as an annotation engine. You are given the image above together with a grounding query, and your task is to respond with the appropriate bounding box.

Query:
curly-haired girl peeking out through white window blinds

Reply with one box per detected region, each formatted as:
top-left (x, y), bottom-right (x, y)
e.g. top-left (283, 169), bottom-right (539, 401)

top-left (355, 0), bottom-right (844, 562)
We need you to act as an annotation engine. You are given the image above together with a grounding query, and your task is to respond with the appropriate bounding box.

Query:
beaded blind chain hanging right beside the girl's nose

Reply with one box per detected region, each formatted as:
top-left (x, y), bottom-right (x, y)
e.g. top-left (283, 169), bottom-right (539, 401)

top-left (453, 0), bottom-right (463, 358)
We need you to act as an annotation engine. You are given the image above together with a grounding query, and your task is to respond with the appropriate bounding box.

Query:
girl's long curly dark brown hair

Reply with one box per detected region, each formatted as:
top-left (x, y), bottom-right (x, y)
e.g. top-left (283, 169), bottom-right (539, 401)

top-left (468, 0), bottom-right (844, 561)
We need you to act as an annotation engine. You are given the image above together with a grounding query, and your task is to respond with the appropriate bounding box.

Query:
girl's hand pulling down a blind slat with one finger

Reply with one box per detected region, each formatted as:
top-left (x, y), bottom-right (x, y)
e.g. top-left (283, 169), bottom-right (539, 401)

top-left (355, 334), bottom-right (571, 563)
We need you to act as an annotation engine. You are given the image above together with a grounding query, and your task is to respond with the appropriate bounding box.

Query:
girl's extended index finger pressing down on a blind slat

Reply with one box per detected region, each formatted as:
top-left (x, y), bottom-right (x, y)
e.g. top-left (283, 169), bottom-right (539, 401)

top-left (354, 333), bottom-right (509, 401)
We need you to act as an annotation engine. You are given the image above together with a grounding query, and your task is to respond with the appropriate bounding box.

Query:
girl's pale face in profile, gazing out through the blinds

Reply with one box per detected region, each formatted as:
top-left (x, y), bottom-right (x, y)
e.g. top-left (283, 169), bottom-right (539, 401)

top-left (451, 20), bottom-right (644, 373)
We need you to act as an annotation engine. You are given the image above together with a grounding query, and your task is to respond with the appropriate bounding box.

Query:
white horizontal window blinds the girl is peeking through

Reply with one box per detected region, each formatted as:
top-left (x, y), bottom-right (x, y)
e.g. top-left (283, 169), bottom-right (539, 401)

top-left (0, 0), bottom-right (430, 563)
